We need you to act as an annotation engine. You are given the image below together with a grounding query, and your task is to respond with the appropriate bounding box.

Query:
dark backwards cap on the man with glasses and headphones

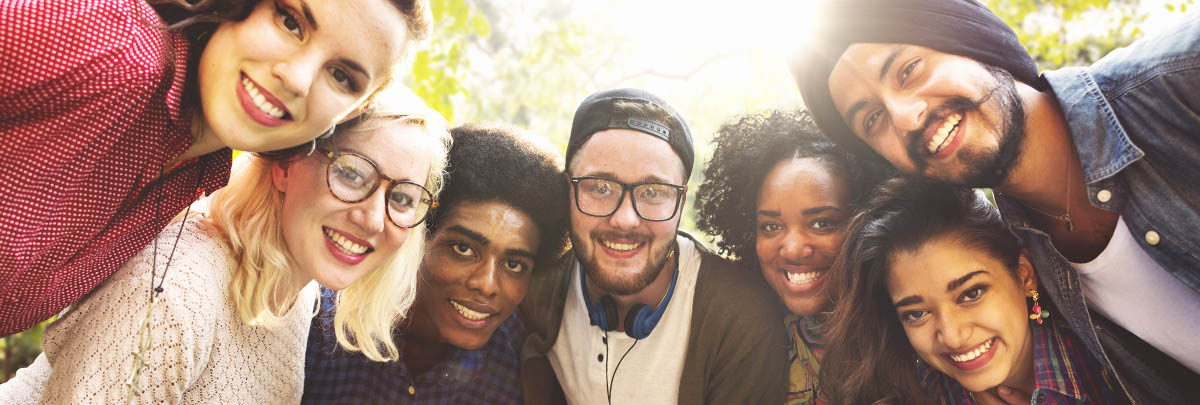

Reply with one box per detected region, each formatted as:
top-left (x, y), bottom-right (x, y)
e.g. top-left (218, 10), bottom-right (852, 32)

top-left (566, 89), bottom-right (696, 177)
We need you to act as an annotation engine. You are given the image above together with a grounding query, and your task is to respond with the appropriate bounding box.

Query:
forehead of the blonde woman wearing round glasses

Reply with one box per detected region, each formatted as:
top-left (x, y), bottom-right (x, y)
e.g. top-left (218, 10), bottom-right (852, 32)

top-left (335, 120), bottom-right (437, 185)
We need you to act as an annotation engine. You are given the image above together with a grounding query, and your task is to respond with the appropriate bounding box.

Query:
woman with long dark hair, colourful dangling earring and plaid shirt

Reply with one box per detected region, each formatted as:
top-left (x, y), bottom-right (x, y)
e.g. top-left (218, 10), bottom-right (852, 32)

top-left (821, 179), bottom-right (1128, 404)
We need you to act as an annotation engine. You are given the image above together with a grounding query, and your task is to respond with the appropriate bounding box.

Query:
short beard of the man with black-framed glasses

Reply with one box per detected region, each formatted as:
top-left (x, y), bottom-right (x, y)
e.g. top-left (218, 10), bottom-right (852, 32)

top-left (570, 230), bottom-right (674, 296)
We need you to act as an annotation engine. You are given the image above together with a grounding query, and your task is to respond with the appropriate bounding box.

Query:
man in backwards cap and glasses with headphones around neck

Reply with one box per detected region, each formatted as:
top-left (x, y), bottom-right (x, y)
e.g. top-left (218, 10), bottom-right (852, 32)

top-left (521, 89), bottom-right (787, 404)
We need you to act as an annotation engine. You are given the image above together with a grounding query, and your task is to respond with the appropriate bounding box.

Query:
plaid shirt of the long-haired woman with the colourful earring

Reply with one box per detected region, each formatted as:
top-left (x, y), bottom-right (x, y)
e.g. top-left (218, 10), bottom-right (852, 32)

top-left (918, 320), bottom-right (1128, 405)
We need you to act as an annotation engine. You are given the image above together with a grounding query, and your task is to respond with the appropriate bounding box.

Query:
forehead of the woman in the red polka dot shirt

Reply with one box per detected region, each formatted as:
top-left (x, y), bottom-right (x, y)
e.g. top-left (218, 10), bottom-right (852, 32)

top-left (302, 0), bottom-right (409, 80)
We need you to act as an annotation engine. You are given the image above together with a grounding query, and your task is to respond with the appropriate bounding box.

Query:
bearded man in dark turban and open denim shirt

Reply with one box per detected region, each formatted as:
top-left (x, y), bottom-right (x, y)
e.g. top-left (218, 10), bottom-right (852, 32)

top-left (792, 0), bottom-right (1200, 403)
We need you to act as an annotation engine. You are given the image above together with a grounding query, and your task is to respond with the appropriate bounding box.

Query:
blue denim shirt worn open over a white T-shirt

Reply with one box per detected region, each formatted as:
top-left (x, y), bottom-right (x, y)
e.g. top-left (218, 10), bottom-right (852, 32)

top-left (996, 14), bottom-right (1200, 403)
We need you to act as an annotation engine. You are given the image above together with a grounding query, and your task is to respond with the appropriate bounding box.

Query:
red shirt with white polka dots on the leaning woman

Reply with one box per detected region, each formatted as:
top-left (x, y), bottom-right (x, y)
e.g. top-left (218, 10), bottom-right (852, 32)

top-left (0, 0), bottom-right (230, 336)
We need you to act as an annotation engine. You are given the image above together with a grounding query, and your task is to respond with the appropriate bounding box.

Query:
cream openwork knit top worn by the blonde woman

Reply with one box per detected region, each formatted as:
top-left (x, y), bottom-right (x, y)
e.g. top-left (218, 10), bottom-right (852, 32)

top-left (0, 217), bottom-right (317, 404)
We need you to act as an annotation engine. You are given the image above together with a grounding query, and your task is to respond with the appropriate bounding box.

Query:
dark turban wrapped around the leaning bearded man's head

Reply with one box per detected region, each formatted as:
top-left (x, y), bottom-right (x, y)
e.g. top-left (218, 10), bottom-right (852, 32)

top-left (791, 0), bottom-right (1044, 157)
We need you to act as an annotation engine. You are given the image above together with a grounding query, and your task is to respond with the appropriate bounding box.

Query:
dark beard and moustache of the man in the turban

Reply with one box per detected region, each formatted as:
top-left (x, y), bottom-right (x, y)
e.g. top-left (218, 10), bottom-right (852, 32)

top-left (907, 66), bottom-right (1025, 187)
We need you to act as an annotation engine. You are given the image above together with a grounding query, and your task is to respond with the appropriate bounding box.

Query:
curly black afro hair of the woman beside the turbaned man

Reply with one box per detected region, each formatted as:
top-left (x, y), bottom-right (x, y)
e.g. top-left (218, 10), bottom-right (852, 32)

top-left (696, 110), bottom-right (892, 271)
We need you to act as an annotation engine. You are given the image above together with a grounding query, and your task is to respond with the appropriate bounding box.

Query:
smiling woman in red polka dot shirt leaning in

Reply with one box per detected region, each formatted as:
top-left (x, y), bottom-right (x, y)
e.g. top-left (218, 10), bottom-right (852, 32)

top-left (0, 0), bottom-right (431, 336)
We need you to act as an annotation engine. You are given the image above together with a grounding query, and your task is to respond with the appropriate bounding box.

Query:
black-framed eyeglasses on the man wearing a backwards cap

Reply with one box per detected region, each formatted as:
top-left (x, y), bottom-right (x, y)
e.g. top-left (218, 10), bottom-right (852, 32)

top-left (571, 176), bottom-right (688, 222)
